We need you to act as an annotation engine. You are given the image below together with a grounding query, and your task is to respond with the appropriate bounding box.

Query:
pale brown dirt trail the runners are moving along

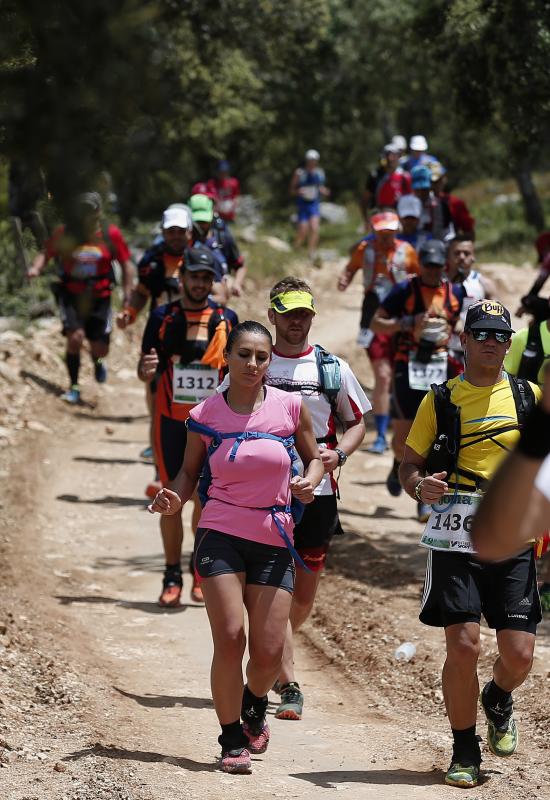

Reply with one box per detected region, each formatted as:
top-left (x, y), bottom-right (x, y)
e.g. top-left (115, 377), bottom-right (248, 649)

top-left (0, 265), bottom-right (550, 800)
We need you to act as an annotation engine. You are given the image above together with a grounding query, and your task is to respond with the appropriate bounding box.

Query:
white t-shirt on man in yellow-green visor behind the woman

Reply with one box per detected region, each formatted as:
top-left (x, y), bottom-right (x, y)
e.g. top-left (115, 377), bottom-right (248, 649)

top-left (217, 347), bottom-right (372, 495)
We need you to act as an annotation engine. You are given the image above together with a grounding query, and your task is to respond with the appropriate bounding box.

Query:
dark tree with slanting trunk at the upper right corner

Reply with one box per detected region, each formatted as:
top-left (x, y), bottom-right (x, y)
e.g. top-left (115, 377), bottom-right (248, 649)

top-left (416, 0), bottom-right (550, 230)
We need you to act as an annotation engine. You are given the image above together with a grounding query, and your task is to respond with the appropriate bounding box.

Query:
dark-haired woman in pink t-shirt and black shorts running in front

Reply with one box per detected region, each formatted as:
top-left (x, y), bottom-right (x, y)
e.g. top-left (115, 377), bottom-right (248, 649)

top-left (150, 321), bottom-right (323, 772)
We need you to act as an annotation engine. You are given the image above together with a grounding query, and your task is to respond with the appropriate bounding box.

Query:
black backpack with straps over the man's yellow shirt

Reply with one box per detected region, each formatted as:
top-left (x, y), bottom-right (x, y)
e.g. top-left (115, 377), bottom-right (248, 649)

top-left (426, 375), bottom-right (535, 491)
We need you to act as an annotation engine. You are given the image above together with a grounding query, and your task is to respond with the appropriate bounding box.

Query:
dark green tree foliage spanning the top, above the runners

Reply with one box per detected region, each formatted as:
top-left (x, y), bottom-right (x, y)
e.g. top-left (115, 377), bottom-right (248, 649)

top-left (0, 0), bottom-right (550, 225)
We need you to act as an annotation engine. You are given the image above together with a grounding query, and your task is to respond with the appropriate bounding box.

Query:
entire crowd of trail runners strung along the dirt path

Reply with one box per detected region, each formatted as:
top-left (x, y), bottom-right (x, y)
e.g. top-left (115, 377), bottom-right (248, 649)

top-left (25, 135), bottom-right (550, 787)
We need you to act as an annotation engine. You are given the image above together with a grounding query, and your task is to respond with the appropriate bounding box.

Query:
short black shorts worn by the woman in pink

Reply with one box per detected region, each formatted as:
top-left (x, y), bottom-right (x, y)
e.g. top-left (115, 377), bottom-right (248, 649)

top-left (193, 528), bottom-right (294, 594)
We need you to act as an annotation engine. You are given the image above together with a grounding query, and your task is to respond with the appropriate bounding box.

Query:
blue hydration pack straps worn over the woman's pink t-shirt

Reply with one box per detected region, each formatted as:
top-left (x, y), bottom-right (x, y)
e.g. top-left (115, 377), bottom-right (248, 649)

top-left (186, 417), bottom-right (311, 572)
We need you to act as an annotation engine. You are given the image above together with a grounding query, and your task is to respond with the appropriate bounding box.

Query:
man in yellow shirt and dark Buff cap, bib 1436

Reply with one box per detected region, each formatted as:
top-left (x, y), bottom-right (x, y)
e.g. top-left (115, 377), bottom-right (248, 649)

top-left (400, 300), bottom-right (541, 786)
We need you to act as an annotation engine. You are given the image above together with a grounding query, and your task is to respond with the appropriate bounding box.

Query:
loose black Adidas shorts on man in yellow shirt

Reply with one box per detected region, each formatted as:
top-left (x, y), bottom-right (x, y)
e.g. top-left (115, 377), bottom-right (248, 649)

top-left (420, 547), bottom-right (542, 633)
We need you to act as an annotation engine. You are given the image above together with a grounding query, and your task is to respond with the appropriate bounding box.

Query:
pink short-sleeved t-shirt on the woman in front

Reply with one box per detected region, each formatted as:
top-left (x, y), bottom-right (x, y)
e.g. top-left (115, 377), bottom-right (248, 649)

top-left (190, 386), bottom-right (302, 547)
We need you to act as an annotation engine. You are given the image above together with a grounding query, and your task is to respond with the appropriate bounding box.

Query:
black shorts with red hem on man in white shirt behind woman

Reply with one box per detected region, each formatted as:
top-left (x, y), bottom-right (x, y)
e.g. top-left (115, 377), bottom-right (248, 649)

top-left (294, 494), bottom-right (344, 572)
